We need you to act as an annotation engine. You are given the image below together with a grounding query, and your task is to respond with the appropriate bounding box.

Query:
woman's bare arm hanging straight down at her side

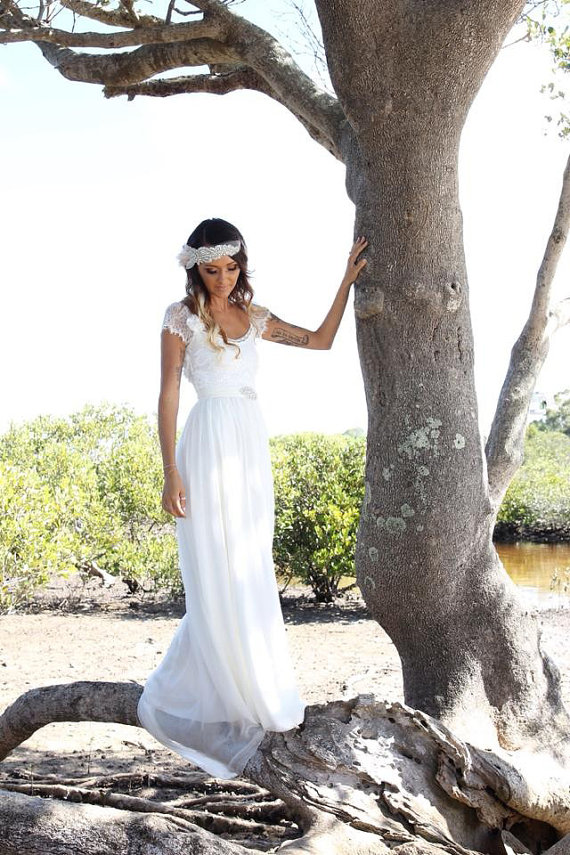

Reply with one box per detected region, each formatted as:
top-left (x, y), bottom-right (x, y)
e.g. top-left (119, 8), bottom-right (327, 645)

top-left (158, 329), bottom-right (186, 517)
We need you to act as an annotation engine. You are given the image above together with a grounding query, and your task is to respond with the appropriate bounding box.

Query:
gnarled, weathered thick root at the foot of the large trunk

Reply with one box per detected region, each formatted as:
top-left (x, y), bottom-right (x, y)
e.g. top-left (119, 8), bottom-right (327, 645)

top-left (245, 695), bottom-right (570, 851)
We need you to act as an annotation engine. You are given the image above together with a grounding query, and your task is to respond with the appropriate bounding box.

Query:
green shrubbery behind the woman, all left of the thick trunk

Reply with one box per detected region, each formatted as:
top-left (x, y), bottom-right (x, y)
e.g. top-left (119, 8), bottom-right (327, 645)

top-left (0, 405), bottom-right (365, 609)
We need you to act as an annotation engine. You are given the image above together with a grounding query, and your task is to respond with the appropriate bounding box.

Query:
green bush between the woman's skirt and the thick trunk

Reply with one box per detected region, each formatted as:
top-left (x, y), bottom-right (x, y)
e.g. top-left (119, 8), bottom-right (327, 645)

top-left (271, 433), bottom-right (366, 602)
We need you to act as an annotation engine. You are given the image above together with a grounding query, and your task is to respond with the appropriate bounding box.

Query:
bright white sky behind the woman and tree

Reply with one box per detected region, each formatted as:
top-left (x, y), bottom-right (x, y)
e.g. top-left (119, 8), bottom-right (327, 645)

top-left (0, 10), bottom-right (570, 442)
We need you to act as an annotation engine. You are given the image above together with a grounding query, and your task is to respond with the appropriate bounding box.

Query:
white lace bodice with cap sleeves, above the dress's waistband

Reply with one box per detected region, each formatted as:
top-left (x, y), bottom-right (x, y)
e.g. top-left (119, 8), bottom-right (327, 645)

top-left (162, 303), bottom-right (269, 394)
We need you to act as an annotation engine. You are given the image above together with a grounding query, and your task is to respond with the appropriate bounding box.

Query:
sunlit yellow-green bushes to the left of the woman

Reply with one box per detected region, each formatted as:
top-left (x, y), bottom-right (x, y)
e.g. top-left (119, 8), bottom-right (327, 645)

top-left (0, 404), bottom-right (180, 609)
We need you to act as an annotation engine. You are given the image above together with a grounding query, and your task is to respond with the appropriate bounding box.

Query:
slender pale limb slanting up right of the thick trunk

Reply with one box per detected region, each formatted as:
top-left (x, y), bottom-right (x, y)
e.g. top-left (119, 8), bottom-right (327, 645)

top-left (485, 153), bottom-right (570, 511)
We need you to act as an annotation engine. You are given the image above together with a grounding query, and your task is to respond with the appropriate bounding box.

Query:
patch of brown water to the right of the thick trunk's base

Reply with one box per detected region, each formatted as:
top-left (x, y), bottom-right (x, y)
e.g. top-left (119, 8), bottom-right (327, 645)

top-left (495, 542), bottom-right (570, 608)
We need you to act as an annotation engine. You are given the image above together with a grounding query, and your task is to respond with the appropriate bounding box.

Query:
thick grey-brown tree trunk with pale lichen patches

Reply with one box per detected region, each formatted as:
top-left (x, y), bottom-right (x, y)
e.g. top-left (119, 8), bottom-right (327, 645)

top-left (317, 0), bottom-right (567, 747)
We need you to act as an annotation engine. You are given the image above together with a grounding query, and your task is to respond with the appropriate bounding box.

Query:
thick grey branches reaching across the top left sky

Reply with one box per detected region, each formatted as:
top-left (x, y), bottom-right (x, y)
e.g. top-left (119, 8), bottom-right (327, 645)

top-left (0, 0), bottom-right (347, 159)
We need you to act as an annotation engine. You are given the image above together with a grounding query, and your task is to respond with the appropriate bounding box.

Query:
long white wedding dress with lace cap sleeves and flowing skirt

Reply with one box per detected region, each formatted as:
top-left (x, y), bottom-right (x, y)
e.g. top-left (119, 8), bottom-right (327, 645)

top-left (138, 303), bottom-right (305, 778)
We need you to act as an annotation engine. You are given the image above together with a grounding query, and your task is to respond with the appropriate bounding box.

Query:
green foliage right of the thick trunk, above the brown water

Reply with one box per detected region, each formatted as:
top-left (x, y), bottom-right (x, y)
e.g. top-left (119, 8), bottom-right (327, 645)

top-left (496, 422), bottom-right (570, 539)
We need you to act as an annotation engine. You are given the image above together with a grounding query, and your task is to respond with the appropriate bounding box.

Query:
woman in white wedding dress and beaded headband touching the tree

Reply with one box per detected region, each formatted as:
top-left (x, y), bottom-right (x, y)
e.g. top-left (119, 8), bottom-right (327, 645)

top-left (138, 219), bottom-right (366, 778)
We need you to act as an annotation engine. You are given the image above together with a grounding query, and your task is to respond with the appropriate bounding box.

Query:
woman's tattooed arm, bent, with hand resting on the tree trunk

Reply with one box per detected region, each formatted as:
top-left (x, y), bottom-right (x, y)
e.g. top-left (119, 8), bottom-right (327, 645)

top-left (263, 237), bottom-right (368, 350)
